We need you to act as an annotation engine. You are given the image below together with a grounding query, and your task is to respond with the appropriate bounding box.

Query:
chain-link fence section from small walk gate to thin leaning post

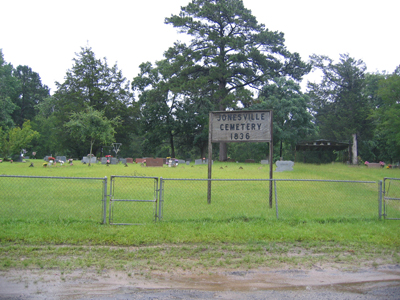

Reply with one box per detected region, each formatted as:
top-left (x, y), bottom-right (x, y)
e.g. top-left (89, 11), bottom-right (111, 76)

top-left (160, 178), bottom-right (274, 221)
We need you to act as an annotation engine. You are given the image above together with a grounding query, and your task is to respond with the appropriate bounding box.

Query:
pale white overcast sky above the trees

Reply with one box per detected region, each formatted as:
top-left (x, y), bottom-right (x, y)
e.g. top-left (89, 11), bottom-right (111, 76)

top-left (0, 0), bottom-right (400, 93)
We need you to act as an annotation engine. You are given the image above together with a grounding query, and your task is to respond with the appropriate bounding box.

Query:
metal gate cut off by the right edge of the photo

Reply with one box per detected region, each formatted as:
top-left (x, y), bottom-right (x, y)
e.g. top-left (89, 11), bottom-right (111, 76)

top-left (383, 178), bottom-right (400, 220)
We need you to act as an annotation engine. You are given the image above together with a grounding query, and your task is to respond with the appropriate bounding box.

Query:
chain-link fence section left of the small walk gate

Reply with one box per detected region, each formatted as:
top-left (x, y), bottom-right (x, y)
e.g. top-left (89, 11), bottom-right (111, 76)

top-left (0, 175), bottom-right (107, 223)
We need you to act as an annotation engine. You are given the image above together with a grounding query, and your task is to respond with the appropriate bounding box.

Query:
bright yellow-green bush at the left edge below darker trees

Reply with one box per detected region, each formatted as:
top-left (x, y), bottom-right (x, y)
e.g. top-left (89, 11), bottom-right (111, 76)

top-left (0, 120), bottom-right (39, 159)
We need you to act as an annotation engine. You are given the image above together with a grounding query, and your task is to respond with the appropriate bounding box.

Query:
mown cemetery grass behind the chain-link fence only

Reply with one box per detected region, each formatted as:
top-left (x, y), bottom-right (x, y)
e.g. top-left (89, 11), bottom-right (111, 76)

top-left (0, 161), bottom-right (400, 224)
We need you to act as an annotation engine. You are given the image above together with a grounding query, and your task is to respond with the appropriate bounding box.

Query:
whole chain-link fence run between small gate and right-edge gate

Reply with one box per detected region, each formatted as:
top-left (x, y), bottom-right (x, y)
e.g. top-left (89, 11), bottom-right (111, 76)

top-left (160, 179), bottom-right (379, 221)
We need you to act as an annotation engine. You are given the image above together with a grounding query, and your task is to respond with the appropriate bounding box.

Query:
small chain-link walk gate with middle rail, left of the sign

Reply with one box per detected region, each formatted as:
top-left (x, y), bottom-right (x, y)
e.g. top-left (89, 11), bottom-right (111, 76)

top-left (109, 176), bottom-right (159, 225)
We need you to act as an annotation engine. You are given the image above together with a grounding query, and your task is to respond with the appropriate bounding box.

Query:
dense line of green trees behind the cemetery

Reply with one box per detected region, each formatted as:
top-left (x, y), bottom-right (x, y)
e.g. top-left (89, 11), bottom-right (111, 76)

top-left (0, 0), bottom-right (400, 163)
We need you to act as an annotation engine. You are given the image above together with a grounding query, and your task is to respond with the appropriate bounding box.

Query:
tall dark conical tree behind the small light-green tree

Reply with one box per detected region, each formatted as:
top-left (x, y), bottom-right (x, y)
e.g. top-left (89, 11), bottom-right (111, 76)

top-left (53, 47), bottom-right (138, 155)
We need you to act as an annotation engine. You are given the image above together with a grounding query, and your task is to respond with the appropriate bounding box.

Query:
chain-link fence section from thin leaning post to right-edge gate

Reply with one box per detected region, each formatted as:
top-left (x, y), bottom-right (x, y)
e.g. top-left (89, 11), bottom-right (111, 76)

top-left (275, 179), bottom-right (380, 219)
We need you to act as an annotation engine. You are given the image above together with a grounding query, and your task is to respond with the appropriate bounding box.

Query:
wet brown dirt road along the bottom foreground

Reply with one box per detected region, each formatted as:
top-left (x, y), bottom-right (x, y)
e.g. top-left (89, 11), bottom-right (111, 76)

top-left (0, 265), bottom-right (400, 300)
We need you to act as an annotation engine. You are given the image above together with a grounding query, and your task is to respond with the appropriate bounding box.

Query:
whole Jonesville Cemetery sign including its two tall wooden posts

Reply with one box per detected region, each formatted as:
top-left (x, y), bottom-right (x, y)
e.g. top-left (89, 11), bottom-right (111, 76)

top-left (207, 110), bottom-right (273, 207)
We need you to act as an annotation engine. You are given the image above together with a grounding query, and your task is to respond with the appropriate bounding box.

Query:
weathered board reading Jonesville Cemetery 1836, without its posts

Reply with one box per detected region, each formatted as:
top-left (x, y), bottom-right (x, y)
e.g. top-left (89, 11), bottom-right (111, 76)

top-left (210, 110), bottom-right (272, 143)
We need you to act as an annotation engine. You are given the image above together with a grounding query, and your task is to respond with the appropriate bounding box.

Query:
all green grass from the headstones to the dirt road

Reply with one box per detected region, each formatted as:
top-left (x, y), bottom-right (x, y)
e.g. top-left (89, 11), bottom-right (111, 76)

top-left (0, 160), bottom-right (400, 269)
